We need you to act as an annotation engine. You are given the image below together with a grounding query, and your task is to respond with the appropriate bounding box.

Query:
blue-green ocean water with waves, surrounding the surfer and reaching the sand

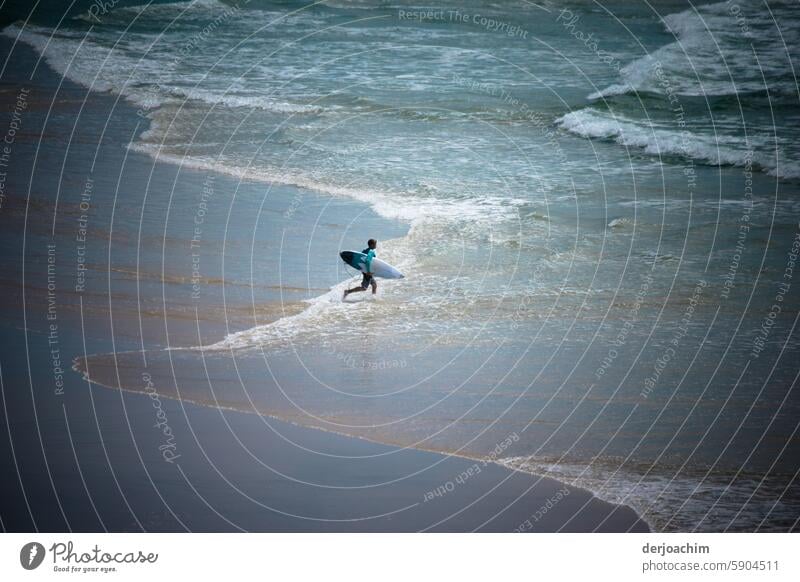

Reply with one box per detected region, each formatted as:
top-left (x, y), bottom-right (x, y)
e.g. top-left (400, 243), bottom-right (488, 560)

top-left (9, 0), bottom-right (800, 531)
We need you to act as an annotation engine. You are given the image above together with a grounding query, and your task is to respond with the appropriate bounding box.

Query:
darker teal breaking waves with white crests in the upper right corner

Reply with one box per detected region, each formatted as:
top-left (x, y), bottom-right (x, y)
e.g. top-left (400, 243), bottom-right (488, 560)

top-left (576, 2), bottom-right (800, 179)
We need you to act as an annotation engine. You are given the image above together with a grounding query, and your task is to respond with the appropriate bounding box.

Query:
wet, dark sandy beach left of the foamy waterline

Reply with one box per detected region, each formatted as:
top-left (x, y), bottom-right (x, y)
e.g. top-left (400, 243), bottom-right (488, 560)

top-left (0, 33), bottom-right (647, 531)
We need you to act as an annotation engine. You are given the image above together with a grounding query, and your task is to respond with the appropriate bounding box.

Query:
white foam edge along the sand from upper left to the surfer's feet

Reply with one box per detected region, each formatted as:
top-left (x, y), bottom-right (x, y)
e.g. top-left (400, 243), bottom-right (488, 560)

top-left (4, 17), bottom-right (525, 356)
